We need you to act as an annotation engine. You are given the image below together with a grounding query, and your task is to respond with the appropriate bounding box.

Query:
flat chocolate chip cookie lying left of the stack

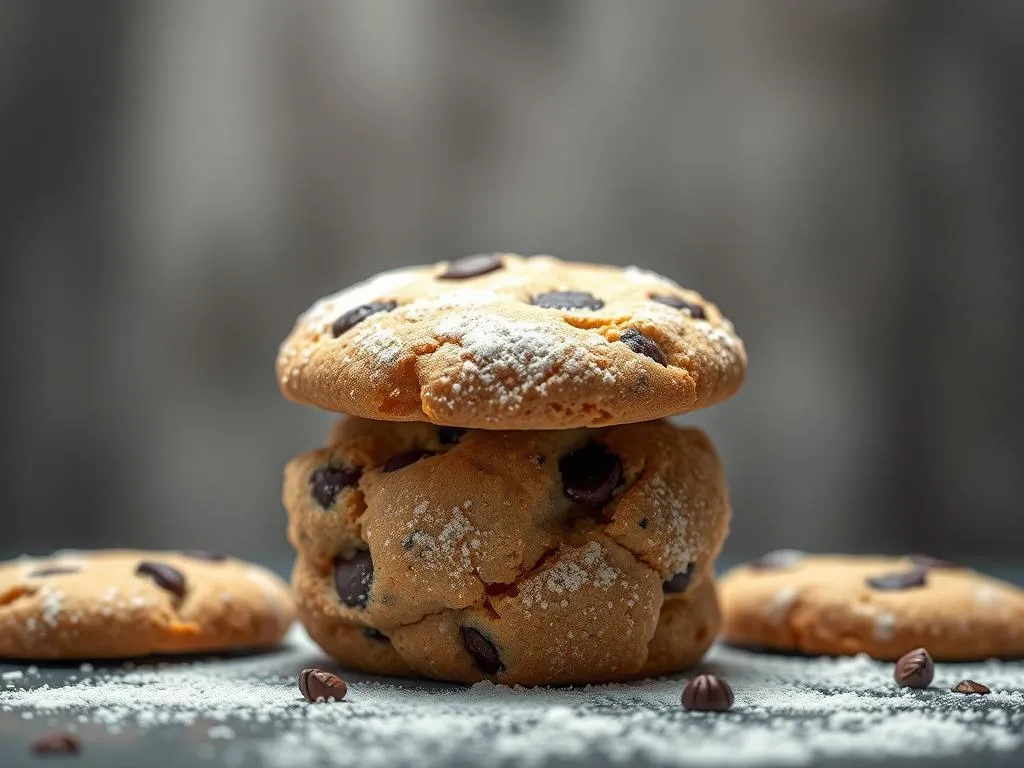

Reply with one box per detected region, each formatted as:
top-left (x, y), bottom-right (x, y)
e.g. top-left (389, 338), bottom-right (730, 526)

top-left (0, 550), bottom-right (295, 659)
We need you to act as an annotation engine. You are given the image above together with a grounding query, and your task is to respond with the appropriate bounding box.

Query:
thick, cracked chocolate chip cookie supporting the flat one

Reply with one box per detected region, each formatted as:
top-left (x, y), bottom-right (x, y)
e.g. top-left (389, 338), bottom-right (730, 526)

top-left (284, 418), bottom-right (729, 684)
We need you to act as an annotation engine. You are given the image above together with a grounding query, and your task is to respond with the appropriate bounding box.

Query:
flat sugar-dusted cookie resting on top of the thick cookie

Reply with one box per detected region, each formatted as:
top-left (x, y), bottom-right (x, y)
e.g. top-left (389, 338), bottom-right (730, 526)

top-left (278, 254), bottom-right (746, 429)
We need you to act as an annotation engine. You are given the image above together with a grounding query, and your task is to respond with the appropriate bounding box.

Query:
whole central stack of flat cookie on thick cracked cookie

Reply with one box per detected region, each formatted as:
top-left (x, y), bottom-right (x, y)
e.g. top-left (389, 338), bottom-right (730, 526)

top-left (278, 254), bottom-right (746, 685)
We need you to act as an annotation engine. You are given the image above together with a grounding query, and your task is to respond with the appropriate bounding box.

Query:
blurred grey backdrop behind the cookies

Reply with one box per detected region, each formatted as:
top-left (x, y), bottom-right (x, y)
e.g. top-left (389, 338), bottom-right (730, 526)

top-left (0, 0), bottom-right (1024, 557)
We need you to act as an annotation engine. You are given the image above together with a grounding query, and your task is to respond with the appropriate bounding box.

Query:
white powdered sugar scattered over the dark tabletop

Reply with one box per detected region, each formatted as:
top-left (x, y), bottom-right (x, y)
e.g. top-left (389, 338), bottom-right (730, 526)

top-left (0, 632), bottom-right (1024, 768)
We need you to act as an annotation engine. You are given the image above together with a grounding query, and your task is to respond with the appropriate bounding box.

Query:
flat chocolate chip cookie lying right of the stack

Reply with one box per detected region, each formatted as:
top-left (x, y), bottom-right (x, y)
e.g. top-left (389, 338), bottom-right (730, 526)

top-left (721, 550), bottom-right (1024, 662)
